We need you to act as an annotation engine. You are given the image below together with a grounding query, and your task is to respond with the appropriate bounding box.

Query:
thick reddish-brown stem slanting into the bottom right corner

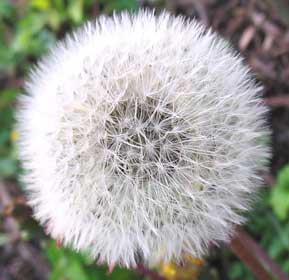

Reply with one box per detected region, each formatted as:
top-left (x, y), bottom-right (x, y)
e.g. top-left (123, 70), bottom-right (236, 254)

top-left (229, 227), bottom-right (289, 280)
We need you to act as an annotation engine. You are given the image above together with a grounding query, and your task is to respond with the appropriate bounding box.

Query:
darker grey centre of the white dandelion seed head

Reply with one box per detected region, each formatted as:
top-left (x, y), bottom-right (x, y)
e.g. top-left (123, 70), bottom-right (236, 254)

top-left (102, 99), bottom-right (186, 180)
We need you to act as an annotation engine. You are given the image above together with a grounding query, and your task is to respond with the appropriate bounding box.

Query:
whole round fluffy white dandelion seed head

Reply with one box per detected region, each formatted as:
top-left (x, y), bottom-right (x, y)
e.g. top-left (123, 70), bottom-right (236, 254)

top-left (18, 12), bottom-right (268, 267)
